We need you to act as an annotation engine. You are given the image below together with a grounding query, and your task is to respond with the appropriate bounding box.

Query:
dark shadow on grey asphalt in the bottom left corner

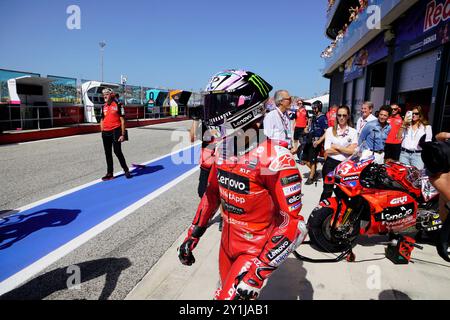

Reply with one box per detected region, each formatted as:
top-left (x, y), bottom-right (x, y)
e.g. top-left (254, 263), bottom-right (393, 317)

top-left (0, 258), bottom-right (131, 300)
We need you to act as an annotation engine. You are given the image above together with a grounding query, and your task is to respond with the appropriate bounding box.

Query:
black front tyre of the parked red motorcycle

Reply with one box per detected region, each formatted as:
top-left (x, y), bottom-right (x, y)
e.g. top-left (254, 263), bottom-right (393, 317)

top-left (308, 207), bottom-right (357, 253)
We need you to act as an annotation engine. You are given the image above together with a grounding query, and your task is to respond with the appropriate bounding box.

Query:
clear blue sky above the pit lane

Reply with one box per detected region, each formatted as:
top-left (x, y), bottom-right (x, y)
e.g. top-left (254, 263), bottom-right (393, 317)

top-left (0, 0), bottom-right (331, 98)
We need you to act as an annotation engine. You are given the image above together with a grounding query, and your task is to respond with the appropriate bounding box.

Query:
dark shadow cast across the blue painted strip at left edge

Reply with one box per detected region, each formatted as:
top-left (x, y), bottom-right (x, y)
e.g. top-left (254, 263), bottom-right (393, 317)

top-left (0, 209), bottom-right (81, 250)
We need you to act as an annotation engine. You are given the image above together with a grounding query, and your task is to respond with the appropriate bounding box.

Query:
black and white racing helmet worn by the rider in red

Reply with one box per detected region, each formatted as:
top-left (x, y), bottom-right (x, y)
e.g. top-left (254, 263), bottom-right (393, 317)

top-left (203, 70), bottom-right (273, 138)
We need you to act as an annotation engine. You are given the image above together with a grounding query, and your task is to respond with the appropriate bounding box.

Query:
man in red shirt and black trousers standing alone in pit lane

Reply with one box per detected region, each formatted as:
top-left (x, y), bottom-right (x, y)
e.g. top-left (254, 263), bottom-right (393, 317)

top-left (100, 88), bottom-right (131, 181)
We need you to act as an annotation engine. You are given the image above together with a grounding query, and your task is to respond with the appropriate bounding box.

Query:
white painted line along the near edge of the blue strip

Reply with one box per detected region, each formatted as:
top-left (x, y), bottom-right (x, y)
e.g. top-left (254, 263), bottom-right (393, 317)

top-left (0, 166), bottom-right (199, 295)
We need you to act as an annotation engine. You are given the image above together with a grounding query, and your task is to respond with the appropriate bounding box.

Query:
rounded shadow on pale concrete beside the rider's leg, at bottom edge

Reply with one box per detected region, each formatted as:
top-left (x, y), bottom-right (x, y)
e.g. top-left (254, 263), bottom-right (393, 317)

top-left (258, 258), bottom-right (314, 300)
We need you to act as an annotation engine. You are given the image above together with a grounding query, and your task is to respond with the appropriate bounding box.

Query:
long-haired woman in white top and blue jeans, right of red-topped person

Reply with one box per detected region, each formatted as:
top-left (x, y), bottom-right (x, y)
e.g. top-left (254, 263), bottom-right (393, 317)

top-left (397, 106), bottom-right (433, 170)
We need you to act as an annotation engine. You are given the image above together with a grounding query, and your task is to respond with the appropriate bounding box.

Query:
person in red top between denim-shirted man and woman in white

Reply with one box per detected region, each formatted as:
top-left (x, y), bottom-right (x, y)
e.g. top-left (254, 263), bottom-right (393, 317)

top-left (384, 104), bottom-right (403, 162)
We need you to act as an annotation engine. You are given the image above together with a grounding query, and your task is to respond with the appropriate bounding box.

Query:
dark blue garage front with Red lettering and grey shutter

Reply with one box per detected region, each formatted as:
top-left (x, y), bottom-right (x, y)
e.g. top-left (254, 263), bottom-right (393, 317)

top-left (389, 0), bottom-right (450, 132)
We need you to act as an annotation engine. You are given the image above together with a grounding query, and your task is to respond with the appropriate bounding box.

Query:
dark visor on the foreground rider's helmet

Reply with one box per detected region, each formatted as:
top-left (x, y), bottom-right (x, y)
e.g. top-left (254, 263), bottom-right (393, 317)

top-left (204, 93), bottom-right (252, 126)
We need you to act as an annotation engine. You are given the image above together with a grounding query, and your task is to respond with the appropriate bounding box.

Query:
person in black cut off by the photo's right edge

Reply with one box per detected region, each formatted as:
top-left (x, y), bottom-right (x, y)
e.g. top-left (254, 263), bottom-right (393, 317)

top-left (420, 132), bottom-right (450, 262)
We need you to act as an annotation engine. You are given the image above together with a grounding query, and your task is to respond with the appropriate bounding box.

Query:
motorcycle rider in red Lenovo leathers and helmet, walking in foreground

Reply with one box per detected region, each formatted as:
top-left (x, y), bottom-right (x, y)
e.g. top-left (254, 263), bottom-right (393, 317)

top-left (179, 70), bottom-right (307, 300)
